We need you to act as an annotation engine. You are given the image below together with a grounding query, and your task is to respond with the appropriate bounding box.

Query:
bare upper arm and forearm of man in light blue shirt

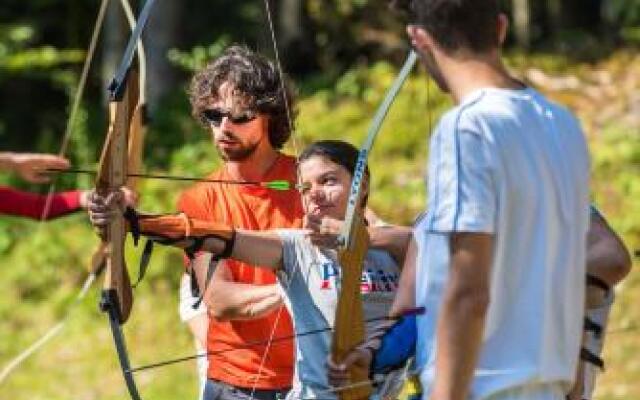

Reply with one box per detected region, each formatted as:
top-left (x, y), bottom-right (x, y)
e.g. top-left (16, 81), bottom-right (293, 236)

top-left (431, 233), bottom-right (494, 400)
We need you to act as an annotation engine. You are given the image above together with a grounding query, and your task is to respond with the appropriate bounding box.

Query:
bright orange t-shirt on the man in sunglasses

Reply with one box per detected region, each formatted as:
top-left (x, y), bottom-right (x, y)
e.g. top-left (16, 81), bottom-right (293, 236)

top-left (178, 155), bottom-right (303, 389)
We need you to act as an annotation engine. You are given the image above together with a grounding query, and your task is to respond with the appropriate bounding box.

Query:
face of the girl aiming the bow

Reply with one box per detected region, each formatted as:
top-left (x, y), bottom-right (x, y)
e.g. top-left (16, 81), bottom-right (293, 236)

top-left (299, 155), bottom-right (351, 220)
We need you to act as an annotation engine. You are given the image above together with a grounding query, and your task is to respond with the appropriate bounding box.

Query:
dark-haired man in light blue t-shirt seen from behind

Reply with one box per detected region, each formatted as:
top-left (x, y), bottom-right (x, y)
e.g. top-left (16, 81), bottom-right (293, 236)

top-left (330, 0), bottom-right (590, 400)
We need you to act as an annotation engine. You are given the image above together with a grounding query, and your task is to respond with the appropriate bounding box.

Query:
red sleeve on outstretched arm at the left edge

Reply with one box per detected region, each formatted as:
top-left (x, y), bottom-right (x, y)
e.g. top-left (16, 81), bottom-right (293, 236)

top-left (0, 186), bottom-right (82, 220)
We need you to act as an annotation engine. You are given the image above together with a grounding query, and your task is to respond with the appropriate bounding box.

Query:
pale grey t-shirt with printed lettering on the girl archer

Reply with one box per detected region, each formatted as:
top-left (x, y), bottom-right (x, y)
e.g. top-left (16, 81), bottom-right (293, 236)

top-left (278, 230), bottom-right (400, 400)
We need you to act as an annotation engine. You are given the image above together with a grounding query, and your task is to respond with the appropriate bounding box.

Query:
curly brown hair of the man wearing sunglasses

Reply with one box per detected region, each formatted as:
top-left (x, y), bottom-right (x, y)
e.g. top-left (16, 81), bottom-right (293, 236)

top-left (189, 45), bottom-right (296, 149)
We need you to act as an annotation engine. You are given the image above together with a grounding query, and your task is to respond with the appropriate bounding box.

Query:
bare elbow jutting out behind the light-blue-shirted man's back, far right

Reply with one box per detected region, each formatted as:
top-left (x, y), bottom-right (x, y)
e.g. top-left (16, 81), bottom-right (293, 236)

top-left (587, 214), bottom-right (631, 287)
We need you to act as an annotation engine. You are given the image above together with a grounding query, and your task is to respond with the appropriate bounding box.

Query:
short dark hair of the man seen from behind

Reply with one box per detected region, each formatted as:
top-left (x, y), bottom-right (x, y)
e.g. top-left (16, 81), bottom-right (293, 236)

top-left (391, 0), bottom-right (500, 52)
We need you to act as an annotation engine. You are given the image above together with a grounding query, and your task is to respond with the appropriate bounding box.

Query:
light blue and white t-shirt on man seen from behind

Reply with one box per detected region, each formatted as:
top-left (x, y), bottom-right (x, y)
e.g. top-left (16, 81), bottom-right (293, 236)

top-left (415, 89), bottom-right (589, 400)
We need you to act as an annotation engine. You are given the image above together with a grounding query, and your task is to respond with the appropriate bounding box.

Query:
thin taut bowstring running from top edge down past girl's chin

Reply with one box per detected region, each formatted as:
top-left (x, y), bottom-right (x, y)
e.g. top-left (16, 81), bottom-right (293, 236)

top-left (249, 0), bottom-right (301, 400)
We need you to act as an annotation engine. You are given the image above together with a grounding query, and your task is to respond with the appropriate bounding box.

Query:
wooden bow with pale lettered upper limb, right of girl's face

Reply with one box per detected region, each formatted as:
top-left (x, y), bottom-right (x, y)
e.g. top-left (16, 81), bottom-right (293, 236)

top-left (332, 50), bottom-right (417, 400)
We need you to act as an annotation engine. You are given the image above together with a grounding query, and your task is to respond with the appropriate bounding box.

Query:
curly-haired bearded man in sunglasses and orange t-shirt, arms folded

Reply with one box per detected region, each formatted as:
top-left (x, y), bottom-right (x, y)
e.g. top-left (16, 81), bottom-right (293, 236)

top-left (178, 46), bottom-right (303, 400)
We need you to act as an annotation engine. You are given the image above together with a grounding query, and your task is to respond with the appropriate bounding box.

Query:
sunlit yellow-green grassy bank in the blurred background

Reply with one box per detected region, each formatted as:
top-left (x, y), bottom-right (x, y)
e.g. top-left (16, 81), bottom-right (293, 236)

top-left (0, 48), bottom-right (640, 400)
